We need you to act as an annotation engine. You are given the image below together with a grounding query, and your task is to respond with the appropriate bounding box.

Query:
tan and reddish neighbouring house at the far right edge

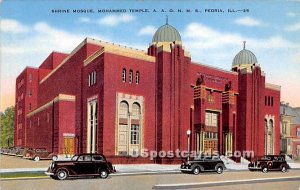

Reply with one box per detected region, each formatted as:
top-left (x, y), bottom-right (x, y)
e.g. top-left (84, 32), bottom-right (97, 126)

top-left (280, 102), bottom-right (300, 159)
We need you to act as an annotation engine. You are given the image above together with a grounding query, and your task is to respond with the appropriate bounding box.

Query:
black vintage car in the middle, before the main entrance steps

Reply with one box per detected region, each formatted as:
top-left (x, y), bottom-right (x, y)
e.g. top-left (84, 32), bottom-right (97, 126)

top-left (180, 156), bottom-right (226, 175)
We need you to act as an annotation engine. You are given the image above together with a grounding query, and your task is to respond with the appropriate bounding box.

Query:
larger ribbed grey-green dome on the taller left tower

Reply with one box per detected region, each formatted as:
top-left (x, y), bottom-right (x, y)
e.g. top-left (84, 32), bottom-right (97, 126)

top-left (152, 23), bottom-right (181, 42)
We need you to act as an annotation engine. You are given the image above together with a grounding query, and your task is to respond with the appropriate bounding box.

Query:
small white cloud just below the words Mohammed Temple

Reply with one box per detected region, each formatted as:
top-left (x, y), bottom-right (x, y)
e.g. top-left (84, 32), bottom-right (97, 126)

top-left (97, 13), bottom-right (135, 26)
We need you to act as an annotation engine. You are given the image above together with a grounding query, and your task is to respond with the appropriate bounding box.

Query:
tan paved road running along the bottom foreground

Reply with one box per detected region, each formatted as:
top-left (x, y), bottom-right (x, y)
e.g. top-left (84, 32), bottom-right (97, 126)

top-left (0, 170), bottom-right (300, 190)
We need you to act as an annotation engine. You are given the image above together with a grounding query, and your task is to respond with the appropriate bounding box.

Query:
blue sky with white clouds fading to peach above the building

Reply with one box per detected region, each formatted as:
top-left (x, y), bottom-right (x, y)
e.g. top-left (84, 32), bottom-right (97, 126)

top-left (0, 0), bottom-right (300, 111)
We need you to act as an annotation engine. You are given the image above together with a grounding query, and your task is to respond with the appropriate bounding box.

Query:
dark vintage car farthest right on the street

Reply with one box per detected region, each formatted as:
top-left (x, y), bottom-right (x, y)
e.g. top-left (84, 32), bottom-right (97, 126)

top-left (248, 155), bottom-right (290, 173)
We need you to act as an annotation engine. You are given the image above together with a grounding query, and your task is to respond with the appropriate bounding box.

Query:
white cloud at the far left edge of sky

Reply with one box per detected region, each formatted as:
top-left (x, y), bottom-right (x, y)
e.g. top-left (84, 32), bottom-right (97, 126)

top-left (0, 19), bottom-right (29, 33)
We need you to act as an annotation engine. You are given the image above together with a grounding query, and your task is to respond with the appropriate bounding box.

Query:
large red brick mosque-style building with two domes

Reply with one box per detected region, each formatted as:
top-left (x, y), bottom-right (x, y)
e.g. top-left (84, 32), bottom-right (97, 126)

top-left (15, 24), bottom-right (280, 162)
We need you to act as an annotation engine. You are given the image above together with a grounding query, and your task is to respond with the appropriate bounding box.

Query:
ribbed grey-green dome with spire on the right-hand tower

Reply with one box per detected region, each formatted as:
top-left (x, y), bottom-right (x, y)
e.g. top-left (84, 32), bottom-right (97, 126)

top-left (232, 42), bottom-right (257, 67)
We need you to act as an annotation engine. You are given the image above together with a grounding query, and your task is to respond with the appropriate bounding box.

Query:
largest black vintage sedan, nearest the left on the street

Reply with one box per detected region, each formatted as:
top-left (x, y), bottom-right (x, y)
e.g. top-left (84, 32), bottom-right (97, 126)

top-left (45, 154), bottom-right (116, 180)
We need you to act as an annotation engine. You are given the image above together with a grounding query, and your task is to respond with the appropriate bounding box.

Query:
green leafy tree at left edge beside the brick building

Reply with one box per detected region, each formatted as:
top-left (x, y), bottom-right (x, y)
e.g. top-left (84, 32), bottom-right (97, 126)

top-left (0, 106), bottom-right (15, 147)
